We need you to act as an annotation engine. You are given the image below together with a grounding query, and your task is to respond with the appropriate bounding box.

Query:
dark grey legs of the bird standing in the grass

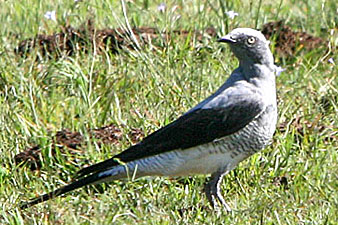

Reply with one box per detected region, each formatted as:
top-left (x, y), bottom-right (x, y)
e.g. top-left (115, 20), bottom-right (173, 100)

top-left (204, 170), bottom-right (231, 212)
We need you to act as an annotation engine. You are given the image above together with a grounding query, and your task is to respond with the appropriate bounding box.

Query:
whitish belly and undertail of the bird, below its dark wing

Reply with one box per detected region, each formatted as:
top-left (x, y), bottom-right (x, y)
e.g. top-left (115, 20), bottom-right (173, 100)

top-left (110, 141), bottom-right (247, 179)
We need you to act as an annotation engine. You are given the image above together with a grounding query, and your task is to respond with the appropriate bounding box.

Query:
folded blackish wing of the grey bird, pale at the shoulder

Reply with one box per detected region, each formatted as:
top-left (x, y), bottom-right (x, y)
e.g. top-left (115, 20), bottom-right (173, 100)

top-left (78, 87), bottom-right (265, 178)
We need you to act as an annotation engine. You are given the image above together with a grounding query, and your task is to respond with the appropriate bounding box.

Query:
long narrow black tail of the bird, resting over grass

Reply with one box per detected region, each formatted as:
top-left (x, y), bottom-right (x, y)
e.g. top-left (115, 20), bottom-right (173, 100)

top-left (20, 173), bottom-right (110, 209)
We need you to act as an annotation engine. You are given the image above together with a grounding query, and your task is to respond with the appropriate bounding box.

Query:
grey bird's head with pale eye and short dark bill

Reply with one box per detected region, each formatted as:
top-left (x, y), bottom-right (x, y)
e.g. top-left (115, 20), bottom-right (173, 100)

top-left (218, 28), bottom-right (274, 65)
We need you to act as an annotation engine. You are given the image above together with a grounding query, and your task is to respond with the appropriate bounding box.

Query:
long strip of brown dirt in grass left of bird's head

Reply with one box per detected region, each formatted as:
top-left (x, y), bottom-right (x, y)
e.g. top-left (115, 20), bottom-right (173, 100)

top-left (14, 20), bottom-right (216, 57)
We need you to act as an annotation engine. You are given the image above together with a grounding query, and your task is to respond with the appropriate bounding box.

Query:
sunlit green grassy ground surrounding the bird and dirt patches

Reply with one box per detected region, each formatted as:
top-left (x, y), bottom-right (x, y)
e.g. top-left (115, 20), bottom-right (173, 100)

top-left (0, 0), bottom-right (338, 224)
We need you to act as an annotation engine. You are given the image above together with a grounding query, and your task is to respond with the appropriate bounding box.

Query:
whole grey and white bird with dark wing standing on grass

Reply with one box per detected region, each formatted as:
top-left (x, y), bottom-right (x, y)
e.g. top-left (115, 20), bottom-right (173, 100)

top-left (20, 28), bottom-right (279, 211)
